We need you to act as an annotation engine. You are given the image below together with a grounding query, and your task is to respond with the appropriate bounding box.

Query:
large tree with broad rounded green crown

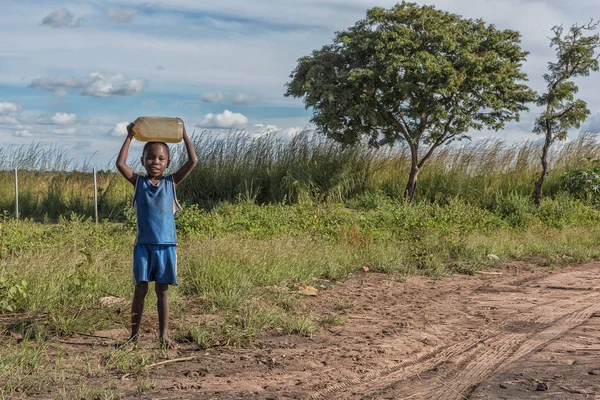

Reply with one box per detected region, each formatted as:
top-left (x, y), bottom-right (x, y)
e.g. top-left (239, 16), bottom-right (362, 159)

top-left (285, 2), bottom-right (534, 201)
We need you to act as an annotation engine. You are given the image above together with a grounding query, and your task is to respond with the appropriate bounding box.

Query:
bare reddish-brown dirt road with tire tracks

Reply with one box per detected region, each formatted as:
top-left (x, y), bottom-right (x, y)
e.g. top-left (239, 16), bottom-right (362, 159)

top-left (25, 263), bottom-right (600, 400)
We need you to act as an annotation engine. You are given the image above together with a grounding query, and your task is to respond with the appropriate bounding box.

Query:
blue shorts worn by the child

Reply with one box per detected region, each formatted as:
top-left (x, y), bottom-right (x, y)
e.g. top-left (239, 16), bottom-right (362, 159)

top-left (133, 244), bottom-right (177, 285)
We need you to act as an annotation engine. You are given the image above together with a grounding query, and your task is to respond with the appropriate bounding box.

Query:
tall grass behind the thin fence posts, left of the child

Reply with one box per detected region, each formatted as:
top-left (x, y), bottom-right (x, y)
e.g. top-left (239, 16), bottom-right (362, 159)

top-left (0, 143), bottom-right (131, 221)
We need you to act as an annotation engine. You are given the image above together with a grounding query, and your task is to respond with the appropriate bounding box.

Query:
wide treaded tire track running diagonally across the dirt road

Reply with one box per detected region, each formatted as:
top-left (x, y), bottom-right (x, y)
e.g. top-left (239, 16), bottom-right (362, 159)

top-left (310, 278), bottom-right (599, 400)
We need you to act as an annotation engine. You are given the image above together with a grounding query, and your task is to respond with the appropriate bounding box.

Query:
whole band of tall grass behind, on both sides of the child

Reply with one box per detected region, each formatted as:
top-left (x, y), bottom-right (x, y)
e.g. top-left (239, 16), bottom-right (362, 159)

top-left (0, 131), bottom-right (600, 220)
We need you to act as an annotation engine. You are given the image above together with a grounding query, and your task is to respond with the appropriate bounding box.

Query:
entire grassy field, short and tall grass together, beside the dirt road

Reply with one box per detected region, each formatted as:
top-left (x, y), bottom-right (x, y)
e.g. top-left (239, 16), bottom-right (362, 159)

top-left (0, 132), bottom-right (600, 398)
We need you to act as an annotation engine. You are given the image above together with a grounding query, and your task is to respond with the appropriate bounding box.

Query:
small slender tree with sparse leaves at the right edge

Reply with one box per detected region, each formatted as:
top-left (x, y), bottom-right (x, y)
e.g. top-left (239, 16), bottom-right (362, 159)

top-left (533, 21), bottom-right (600, 204)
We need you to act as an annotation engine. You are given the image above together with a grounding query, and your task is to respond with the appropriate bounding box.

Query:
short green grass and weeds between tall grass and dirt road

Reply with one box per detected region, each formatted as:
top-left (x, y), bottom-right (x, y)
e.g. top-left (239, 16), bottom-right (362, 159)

top-left (0, 202), bottom-right (600, 398)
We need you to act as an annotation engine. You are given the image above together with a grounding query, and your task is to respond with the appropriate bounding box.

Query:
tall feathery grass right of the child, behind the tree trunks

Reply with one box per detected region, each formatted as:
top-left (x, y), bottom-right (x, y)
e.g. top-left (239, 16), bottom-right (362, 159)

top-left (174, 131), bottom-right (600, 208)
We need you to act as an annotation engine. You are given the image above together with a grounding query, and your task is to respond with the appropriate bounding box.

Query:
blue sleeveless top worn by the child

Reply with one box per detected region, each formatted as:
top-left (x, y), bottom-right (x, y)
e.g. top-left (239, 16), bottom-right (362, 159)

top-left (132, 175), bottom-right (181, 244)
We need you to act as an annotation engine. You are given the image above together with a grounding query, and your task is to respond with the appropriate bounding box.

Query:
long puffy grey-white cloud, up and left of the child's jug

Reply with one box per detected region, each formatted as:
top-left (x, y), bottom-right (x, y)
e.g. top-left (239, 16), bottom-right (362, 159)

top-left (29, 72), bottom-right (146, 97)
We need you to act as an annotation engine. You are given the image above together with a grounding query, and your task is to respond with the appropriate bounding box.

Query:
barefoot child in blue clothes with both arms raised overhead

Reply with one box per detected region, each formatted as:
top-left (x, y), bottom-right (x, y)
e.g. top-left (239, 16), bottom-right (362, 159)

top-left (117, 123), bottom-right (198, 349)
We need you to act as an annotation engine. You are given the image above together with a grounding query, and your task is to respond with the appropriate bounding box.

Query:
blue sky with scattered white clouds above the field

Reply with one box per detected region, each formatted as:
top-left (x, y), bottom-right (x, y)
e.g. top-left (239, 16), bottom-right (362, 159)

top-left (0, 0), bottom-right (600, 169)
